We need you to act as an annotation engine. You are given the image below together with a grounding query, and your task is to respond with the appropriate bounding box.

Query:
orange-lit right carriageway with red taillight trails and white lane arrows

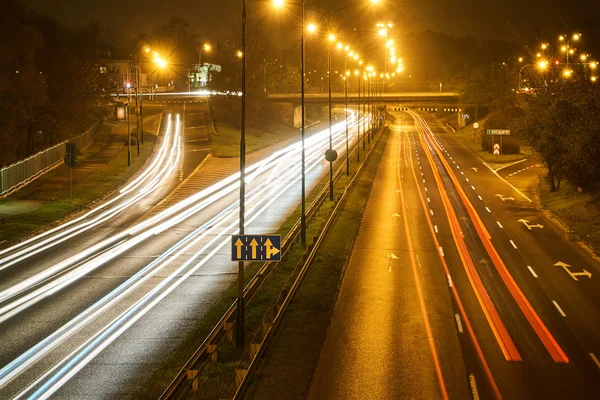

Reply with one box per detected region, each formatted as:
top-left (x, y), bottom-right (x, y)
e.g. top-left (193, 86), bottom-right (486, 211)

top-left (310, 112), bottom-right (600, 399)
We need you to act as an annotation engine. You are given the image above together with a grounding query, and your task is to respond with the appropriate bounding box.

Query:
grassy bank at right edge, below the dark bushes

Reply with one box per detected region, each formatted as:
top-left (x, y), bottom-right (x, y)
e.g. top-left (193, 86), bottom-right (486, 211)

top-left (539, 179), bottom-right (600, 254)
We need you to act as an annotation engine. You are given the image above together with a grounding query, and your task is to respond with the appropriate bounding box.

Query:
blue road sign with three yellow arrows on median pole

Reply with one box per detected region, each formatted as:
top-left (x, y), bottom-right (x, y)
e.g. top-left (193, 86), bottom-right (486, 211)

top-left (231, 235), bottom-right (281, 261)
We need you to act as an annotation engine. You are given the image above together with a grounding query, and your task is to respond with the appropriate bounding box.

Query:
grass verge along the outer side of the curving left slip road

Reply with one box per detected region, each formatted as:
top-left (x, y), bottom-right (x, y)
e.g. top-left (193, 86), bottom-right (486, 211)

top-left (0, 126), bottom-right (156, 244)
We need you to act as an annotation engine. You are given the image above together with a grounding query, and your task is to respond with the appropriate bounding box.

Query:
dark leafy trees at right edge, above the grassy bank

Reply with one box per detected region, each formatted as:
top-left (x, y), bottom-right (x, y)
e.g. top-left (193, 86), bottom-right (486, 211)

top-left (512, 79), bottom-right (600, 191)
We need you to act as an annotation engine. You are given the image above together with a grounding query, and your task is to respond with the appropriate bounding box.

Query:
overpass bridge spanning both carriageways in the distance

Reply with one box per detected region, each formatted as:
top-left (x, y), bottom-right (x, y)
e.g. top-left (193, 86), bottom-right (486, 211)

top-left (268, 92), bottom-right (462, 127)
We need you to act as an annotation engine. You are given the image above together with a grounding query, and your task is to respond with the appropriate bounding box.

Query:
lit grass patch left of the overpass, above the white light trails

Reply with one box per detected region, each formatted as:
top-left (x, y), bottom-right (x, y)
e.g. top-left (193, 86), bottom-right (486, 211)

top-left (210, 123), bottom-right (300, 158)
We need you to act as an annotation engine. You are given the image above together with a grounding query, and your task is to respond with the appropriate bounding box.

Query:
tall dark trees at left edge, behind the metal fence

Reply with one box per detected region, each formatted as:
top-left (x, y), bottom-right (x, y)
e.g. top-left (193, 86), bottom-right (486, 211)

top-left (0, 0), bottom-right (113, 165)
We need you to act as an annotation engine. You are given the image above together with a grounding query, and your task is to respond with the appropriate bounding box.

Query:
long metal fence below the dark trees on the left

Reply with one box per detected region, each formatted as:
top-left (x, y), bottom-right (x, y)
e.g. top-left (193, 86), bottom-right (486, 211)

top-left (0, 122), bottom-right (100, 197)
